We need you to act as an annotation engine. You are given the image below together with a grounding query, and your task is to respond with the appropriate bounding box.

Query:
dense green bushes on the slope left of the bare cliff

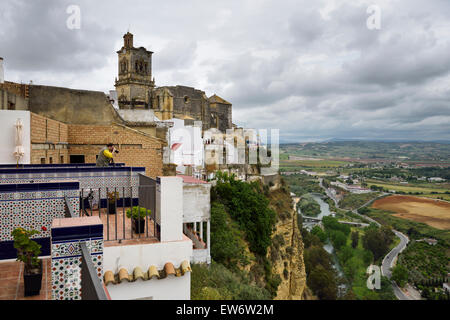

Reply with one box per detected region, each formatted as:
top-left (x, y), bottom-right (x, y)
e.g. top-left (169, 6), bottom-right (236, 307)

top-left (191, 172), bottom-right (281, 300)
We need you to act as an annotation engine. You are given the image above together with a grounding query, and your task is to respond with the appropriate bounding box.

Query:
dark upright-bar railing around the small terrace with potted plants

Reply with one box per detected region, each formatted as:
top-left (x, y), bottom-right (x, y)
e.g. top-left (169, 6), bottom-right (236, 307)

top-left (80, 182), bottom-right (160, 242)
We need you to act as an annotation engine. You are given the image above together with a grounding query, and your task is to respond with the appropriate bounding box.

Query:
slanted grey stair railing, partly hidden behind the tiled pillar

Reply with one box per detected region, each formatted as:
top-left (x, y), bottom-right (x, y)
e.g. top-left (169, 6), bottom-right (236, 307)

top-left (64, 196), bottom-right (108, 300)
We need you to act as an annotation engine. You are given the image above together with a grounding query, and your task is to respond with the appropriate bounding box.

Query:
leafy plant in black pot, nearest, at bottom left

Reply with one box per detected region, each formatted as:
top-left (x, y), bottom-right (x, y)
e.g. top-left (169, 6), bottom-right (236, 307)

top-left (11, 227), bottom-right (47, 297)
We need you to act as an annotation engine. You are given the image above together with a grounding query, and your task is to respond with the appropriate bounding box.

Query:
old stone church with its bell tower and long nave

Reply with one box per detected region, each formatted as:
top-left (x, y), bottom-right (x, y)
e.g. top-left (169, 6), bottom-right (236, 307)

top-left (115, 32), bottom-right (232, 133)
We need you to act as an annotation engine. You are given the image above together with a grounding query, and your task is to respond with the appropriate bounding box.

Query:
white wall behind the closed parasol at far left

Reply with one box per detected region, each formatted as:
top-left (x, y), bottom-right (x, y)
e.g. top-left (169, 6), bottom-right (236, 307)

top-left (0, 110), bottom-right (31, 164)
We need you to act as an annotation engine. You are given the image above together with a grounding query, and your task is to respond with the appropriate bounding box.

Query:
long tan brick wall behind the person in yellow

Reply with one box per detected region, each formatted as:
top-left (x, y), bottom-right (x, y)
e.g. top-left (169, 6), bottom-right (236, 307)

top-left (68, 124), bottom-right (164, 177)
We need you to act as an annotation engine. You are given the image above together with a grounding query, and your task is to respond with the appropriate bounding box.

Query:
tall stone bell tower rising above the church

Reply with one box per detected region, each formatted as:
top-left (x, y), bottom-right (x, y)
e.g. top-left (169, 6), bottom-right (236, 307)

top-left (115, 32), bottom-right (155, 109)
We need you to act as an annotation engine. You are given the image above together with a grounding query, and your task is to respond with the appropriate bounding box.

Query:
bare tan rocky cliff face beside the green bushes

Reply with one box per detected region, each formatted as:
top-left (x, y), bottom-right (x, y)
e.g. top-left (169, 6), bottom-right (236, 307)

top-left (268, 188), bottom-right (310, 300)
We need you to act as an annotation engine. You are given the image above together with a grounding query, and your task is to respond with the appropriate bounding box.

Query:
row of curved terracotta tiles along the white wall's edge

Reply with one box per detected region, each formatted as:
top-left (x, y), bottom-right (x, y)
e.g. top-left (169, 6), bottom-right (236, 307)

top-left (103, 260), bottom-right (192, 286)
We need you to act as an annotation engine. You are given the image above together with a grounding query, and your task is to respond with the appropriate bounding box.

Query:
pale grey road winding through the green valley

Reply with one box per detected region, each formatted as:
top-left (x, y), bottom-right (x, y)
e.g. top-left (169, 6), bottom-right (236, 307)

top-left (320, 179), bottom-right (418, 300)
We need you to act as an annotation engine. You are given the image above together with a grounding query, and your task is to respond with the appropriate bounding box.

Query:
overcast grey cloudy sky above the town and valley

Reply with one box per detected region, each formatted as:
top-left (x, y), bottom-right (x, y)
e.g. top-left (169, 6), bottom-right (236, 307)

top-left (0, 0), bottom-right (450, 142)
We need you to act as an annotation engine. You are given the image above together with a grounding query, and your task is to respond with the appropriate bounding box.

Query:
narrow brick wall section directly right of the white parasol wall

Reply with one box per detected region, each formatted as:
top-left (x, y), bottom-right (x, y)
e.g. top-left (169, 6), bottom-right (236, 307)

top-left (30, 113), bottom-right (69, 164)
